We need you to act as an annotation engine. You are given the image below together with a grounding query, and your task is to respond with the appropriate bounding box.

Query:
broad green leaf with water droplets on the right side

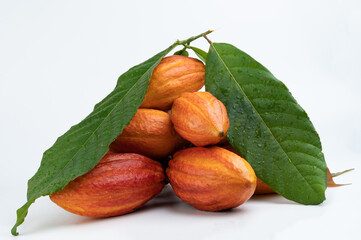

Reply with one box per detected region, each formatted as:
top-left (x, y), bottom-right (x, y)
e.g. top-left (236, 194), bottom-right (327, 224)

top-left (205, 43), bottom-right (327, 204)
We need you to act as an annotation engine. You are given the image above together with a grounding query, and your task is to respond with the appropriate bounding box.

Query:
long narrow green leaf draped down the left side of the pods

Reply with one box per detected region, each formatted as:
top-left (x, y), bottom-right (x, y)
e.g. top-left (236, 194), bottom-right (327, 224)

top-left (11, 45), bottom-right (176, 235)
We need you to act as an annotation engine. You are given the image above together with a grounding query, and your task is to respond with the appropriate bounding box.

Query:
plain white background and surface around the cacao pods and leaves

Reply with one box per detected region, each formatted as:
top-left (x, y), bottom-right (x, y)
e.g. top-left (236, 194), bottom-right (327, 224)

top-left (0, 0), bottom-right (361, 239)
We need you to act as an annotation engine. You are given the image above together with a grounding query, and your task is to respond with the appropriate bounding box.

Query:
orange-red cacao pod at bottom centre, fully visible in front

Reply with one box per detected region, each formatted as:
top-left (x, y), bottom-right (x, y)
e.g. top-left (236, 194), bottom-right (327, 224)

top-left (166, 146), bottom-right (257, 211)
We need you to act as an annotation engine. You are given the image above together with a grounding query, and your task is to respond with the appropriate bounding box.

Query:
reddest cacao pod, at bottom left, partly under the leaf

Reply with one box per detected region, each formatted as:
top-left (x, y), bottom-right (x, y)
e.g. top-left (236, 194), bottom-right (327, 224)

top-left (50, 153), bottom-right (165, 217)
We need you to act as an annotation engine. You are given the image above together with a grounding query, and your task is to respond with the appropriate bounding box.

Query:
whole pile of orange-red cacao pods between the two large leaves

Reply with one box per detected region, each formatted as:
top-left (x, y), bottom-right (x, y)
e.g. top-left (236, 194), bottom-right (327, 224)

top-left (50, 55), bottom-right (273, 217)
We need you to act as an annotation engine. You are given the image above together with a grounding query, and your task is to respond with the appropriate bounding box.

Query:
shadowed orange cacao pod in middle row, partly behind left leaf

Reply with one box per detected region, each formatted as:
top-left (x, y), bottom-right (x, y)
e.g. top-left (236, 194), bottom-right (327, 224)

top-left (109, 109), bottom-right (186, 159)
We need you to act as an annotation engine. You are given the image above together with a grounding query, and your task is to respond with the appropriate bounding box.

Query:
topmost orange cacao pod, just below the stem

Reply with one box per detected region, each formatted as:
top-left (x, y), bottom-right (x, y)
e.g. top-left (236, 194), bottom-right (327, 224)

top-left (140, 55), bottom-right (205, 110)
